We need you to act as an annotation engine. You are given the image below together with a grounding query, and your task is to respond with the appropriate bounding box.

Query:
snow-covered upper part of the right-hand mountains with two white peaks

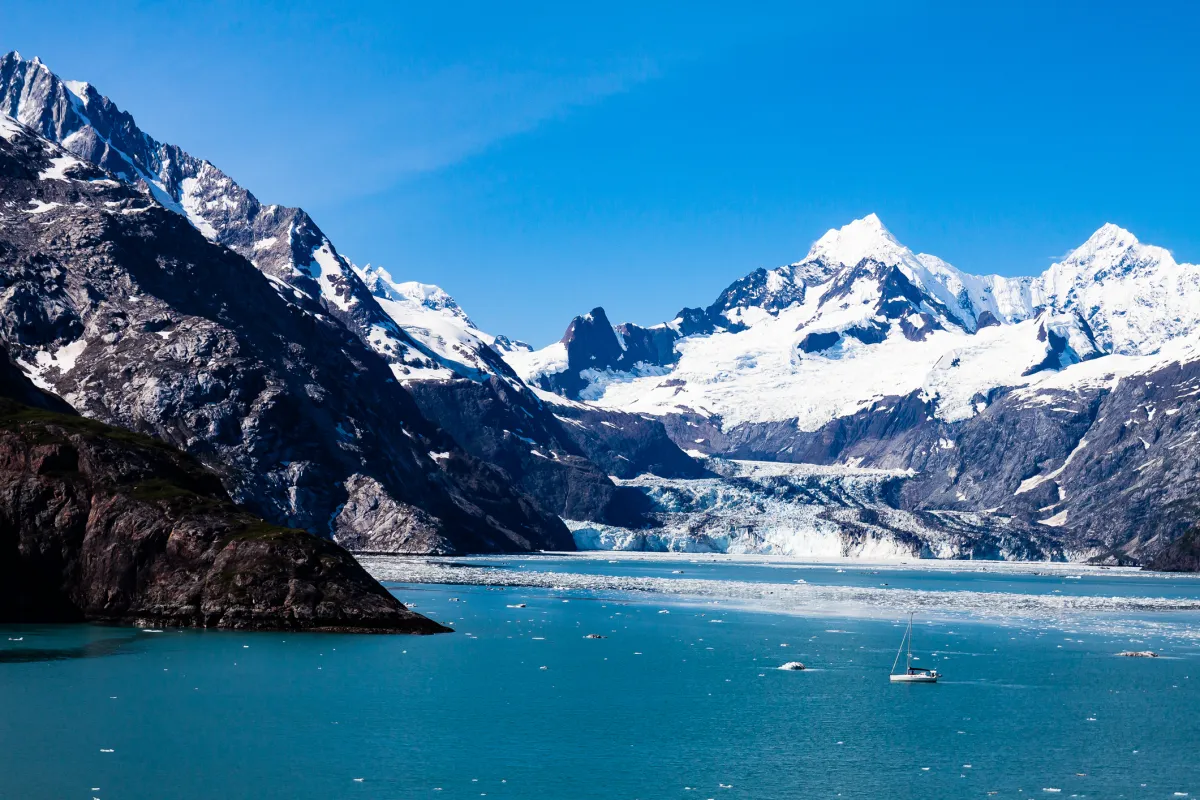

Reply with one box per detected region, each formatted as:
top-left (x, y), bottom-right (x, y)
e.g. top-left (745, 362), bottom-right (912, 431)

top-left (509, 215), bottom-right (1200, 429)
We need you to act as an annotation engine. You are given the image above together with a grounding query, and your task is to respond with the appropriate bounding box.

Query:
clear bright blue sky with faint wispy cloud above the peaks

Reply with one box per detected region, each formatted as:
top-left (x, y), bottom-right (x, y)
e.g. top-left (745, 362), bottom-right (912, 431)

top-left (0, 0), bottom-right (1200, 347)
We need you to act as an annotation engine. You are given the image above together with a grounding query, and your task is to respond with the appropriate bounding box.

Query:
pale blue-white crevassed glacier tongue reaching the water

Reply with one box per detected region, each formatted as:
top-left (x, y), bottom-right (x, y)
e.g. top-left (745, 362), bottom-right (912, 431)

top-left (564, 458), bottom-right (1064, 560)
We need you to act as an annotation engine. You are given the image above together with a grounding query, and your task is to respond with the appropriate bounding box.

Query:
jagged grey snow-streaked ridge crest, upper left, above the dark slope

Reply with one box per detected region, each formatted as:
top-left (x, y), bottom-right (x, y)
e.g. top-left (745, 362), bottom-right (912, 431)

top-left (0, 53), bottom-right (465, 379)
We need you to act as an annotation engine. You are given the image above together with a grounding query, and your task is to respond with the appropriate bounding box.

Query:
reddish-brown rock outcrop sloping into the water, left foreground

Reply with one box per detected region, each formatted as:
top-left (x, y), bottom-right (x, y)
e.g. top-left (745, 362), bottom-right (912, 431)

top-left (0, 350), bottom-right (448, 633)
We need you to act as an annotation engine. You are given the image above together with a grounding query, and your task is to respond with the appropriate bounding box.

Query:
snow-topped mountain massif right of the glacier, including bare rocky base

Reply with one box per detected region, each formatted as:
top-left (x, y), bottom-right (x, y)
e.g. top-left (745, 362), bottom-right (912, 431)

top-left (510, 215), bottom-right (1200, 564)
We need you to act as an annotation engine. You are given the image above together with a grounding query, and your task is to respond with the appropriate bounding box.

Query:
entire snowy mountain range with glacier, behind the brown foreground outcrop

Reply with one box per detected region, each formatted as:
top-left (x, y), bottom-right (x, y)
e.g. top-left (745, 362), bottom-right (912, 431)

top-left (0, 53), bottom-right (1200, 563)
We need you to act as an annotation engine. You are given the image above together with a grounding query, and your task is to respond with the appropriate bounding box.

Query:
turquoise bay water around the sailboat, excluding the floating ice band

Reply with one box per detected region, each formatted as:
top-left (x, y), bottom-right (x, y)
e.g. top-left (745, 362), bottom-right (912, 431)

top-left (0, 559), bottom-right (1200, 800)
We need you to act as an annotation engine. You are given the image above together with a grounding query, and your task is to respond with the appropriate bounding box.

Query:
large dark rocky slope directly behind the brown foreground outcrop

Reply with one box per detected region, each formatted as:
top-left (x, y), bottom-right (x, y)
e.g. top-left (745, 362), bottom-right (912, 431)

top-left (0, 106), bottom-right (571, 553)
